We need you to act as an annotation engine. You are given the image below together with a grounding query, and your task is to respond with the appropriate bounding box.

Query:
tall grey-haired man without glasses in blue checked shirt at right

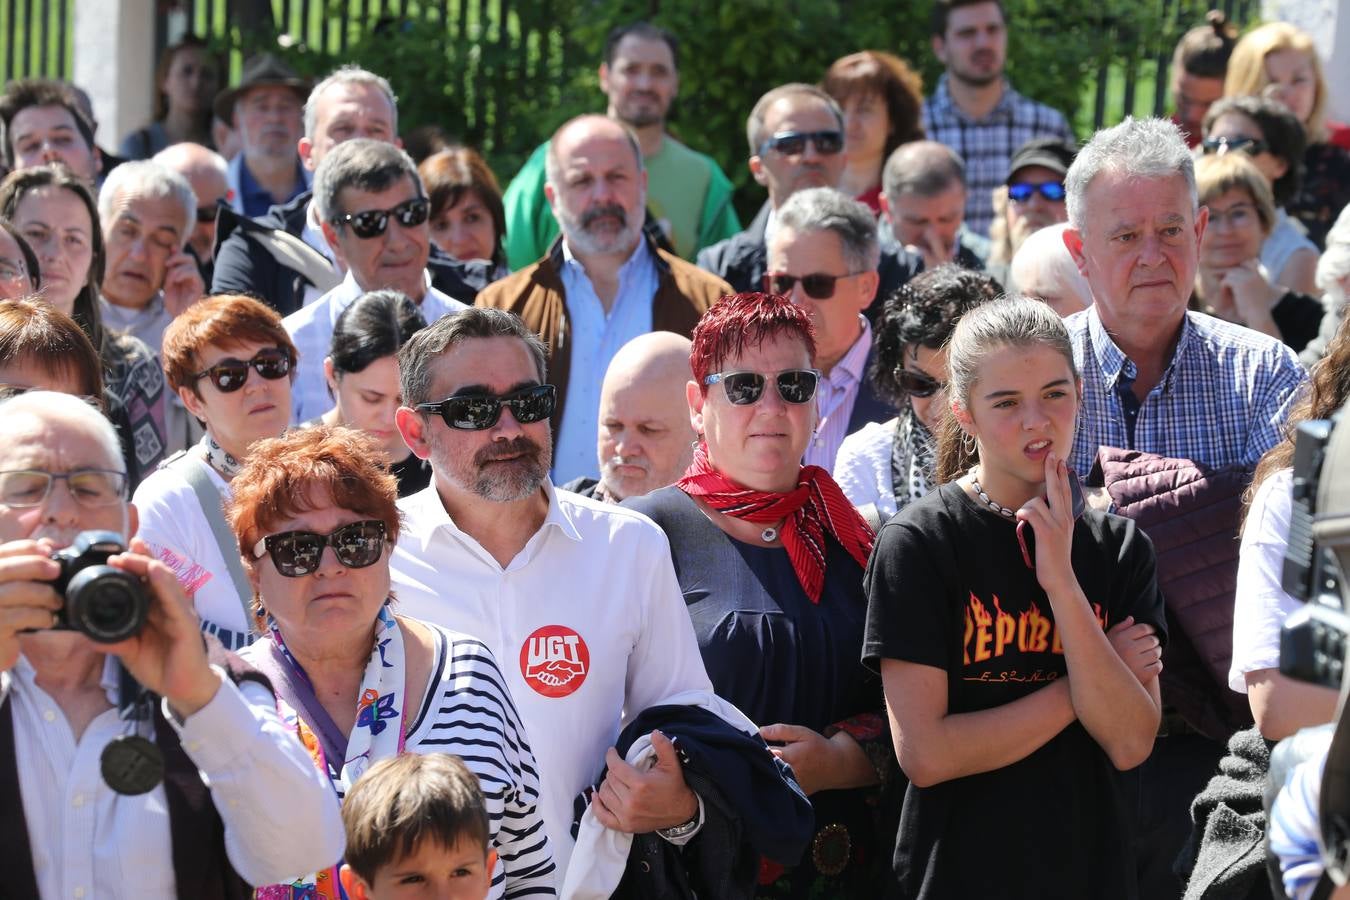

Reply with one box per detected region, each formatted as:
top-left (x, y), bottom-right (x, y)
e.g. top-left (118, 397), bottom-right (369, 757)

top-left (1064, 117), bottom-right (1304, 897)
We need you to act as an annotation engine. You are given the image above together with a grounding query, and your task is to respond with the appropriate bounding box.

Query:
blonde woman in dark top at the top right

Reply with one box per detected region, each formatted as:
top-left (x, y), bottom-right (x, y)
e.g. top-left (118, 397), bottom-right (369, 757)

top-left (1223, 22), bottom-right (1350, 247)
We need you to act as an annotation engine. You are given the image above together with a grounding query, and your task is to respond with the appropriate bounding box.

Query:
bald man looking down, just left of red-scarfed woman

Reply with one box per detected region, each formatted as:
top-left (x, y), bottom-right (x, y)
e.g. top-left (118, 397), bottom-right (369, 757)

top-left (563, 331), bottom-right (698, 503)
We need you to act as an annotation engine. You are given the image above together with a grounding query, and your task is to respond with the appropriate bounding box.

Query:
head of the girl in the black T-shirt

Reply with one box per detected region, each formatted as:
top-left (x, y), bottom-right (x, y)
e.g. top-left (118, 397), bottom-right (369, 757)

top-left (938, 297), bottom-right (1079, 482)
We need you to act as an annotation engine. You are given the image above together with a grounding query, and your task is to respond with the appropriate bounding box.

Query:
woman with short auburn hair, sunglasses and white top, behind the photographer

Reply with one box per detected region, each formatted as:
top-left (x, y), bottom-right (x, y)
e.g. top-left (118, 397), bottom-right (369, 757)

top-left (132, 294), bottom-right (296, 650)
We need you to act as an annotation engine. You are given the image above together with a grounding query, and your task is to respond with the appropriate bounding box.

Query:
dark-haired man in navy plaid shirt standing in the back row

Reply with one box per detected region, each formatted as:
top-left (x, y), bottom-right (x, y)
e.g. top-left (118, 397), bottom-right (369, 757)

top-left (923, 0), bottom-right (1073, 235)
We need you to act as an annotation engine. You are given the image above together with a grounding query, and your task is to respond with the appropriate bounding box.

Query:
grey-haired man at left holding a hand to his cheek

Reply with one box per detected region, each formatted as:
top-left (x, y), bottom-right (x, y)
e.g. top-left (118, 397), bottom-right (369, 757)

top-left (99, 161), bottom-right (205, 352)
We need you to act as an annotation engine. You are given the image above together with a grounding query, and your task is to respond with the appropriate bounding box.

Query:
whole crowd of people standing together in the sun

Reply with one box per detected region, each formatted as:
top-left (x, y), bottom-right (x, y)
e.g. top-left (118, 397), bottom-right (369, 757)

top-left (0, 0), bottom-right (1350, 900)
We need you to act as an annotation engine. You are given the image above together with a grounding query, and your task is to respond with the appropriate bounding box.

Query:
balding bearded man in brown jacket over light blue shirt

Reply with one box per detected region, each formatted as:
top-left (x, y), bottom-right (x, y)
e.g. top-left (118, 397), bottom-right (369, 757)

top-left (475, 115), bottom-right (730, 482)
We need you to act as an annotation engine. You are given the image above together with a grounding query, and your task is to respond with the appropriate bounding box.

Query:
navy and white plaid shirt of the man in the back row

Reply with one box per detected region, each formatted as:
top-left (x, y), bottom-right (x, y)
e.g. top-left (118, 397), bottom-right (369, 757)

top-left (923, 76), bottom-right (1073, 237)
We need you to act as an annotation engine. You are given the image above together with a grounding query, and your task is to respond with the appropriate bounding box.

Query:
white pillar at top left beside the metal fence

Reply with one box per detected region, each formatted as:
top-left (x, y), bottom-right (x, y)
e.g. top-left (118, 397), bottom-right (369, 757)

top-left (73, 0), bottom-right (155, 152)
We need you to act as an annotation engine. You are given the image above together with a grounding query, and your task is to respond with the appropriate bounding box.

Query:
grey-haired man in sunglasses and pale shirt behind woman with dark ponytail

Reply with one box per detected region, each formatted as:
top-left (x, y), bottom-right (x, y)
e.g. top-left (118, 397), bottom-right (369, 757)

top-left (284, 138), bottom-right (466, 422)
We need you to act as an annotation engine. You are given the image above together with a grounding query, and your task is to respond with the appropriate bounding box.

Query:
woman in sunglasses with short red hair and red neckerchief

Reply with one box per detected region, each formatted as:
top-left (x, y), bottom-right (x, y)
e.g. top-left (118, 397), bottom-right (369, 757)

top-left (624, 293), bottom-right (895, 897)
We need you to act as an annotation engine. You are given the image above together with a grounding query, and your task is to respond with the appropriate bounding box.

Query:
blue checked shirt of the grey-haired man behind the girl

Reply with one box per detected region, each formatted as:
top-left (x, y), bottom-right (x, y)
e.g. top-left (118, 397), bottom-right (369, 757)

top-left (1065, 306), bottom-right (1307, 476)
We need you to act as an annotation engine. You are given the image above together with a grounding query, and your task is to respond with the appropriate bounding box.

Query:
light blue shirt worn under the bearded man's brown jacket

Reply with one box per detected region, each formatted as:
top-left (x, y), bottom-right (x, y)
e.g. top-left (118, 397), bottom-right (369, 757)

top-left (554, 237), bottom-right (660, 484)
